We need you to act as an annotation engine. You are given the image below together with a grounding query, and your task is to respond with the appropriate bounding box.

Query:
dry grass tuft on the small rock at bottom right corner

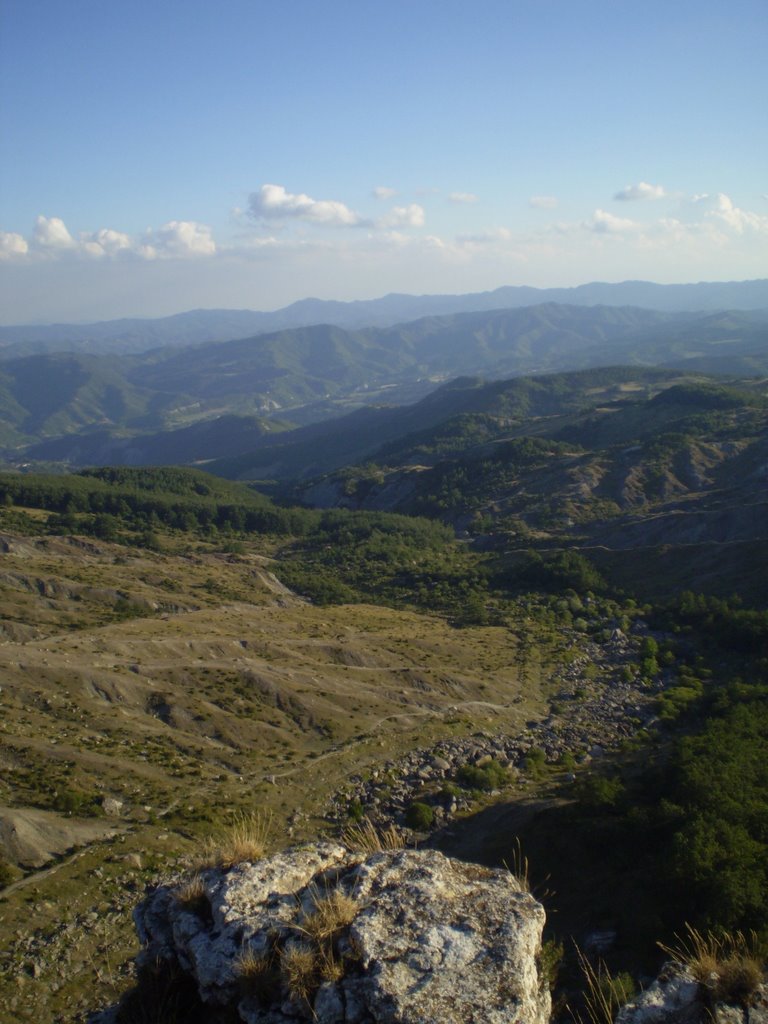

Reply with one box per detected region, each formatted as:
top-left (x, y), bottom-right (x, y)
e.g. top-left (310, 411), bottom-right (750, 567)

top-left (658, 925), bottom-right (766, 1006)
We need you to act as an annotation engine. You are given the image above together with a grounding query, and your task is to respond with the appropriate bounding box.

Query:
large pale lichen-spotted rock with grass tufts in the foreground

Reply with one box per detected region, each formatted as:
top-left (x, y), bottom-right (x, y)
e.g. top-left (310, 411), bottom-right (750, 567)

top-left (135, 844), bottom-right (550, 1024)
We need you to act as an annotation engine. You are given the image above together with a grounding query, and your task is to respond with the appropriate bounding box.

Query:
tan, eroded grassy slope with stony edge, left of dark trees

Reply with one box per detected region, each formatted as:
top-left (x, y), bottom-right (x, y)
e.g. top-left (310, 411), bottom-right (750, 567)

top-left (0, 535), bottom-right (652, 1024)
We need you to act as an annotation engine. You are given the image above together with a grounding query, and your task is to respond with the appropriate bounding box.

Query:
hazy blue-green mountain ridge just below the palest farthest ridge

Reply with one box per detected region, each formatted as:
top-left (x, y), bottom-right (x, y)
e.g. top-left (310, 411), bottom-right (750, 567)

top-left (6, 303), bottom-right (768, 464)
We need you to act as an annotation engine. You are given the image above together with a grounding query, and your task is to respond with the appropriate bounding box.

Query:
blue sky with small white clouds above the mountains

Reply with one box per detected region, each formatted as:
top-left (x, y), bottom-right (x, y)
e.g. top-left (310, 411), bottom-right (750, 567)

top-left (0, 0), bottom-right (768, 324)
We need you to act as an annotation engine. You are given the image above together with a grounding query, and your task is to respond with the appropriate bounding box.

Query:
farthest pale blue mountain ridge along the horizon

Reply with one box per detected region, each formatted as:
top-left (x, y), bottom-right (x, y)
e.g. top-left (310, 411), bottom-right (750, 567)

top-left (0, 280), bottom-right (768, 358)
